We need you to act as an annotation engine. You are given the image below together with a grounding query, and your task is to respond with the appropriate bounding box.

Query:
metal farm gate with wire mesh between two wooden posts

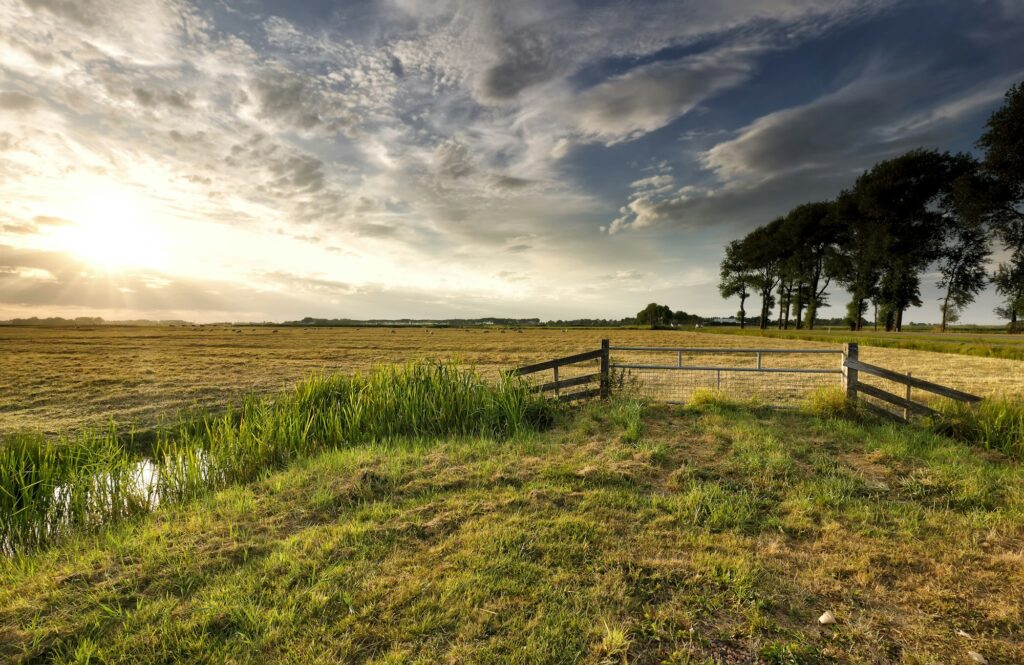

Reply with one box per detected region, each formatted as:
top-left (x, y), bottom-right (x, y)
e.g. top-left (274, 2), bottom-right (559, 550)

top-left (610, 346), bottom-right (843, 406)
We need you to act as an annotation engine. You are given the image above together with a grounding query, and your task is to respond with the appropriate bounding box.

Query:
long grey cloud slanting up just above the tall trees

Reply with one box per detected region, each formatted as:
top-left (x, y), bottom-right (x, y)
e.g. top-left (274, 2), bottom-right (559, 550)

top-left (602, 64), bottom-right (1015, 234)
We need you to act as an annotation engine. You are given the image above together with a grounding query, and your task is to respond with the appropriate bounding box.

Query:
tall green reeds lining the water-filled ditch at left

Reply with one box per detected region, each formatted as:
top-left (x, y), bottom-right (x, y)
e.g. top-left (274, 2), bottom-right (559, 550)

top-left (0, 361), bottom-right (554, 553)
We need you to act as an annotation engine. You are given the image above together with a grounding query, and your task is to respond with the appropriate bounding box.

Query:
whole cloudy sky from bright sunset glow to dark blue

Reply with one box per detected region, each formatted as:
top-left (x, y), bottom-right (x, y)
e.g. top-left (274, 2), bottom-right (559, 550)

top-left (0, 0), bottom-right (1024, 323)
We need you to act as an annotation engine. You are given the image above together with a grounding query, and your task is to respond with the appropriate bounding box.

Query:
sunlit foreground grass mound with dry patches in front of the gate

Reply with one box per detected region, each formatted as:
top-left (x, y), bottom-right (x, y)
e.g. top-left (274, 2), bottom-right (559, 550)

top-left (0, 394), bottom-right (1024, 664)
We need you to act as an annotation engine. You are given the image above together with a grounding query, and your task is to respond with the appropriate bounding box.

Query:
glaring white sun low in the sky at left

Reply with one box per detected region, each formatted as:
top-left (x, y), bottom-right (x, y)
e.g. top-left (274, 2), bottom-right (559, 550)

top-left (51, 189), bottom-right (168, 272)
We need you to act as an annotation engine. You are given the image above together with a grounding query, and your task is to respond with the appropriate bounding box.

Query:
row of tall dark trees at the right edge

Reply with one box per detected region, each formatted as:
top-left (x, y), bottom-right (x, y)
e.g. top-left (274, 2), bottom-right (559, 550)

top-left (719, 84), bottom-right (1024, 332)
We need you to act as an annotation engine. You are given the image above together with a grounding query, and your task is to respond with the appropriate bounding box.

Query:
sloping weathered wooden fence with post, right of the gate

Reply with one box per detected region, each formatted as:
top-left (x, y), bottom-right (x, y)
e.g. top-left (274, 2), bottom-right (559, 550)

top-left (843, 343), bottom-right (981, 421)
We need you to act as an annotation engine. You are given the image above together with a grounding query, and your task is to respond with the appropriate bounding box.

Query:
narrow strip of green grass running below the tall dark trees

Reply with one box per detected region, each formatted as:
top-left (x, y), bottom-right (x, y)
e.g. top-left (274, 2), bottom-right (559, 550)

top-left (697, 327), bottom-right (1024, 361)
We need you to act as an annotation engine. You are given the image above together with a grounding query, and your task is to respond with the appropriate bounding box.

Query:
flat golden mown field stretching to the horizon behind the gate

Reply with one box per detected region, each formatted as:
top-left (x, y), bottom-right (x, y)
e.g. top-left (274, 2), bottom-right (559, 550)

top-left (6, 327), bottom-right (1024, 433)
